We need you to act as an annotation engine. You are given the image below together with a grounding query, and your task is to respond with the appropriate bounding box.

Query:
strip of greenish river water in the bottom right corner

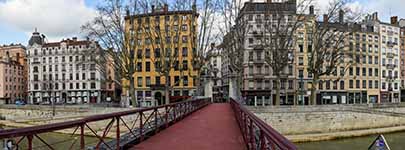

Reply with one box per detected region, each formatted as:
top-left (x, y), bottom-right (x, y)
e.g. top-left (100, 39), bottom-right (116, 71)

top-left (296, 132), bottom-right (405, 150)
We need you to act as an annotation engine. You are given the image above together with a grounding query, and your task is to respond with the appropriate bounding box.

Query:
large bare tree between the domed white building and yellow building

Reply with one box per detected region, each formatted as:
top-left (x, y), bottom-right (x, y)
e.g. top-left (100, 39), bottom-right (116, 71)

top-left (82, 0), bottom-right (147, 106)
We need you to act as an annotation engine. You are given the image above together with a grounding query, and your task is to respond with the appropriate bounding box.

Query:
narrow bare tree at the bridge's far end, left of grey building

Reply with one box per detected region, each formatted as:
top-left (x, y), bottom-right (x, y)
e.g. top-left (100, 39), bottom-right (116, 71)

top-left (219, 0), bottom-right (250, 100)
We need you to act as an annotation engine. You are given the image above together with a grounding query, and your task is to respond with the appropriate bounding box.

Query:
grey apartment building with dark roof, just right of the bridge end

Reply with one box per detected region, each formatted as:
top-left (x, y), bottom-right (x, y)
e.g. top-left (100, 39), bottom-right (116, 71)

top-left (237, 0), bottom-right (297, 105)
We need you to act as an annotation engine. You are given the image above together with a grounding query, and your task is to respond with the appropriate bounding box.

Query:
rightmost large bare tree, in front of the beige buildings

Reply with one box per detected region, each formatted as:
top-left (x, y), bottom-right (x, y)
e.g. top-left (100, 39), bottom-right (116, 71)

top-left (305, 0), bottom-right (360, 105)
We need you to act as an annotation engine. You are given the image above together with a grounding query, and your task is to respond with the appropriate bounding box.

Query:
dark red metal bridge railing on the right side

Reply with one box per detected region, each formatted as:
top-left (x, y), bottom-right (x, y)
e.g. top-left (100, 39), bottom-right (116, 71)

top-left (230, 99), bottom-right (297, 150)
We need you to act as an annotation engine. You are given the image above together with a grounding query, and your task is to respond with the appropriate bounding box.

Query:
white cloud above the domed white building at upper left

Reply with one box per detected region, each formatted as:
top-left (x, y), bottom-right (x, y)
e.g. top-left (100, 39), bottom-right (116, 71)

top-left (0, 0), bottom-right (96, 41)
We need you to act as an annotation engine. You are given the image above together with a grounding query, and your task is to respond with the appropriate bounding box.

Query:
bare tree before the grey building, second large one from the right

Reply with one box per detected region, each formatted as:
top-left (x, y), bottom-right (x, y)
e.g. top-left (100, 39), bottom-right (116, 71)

top-left (253, 0), bottom-right (312, 105)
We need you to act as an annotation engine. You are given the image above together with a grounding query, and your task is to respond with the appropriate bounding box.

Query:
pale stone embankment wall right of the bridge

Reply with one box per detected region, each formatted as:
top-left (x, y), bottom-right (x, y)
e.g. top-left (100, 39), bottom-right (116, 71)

top-left (249, 104), bottom-right (405, 143)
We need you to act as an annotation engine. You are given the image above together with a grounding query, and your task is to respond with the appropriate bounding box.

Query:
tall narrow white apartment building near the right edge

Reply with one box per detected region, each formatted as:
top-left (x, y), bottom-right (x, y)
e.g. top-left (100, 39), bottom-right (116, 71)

top-left (365, 13), bottom-right (401, 103)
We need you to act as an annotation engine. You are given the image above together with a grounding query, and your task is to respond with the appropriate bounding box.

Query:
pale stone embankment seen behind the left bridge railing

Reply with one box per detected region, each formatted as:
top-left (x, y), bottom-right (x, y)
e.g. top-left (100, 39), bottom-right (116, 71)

top-left (0, 105), bottom-right (134, 138)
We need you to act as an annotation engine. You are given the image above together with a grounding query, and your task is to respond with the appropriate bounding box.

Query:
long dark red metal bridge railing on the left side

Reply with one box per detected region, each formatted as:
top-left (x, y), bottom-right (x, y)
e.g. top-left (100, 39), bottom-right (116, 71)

top-left (0, 99), bottom-right (210, 150)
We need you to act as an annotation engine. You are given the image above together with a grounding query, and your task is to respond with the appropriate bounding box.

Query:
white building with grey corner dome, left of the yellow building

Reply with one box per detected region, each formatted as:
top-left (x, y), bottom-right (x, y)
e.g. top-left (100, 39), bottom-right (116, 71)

top-left (27, 31), bottom-right (106, 104)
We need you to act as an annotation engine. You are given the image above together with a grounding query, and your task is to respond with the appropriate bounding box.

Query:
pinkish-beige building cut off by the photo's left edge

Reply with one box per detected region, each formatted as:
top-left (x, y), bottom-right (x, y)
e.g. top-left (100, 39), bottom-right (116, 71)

top-left (0, 44), bottom-right (28, 104)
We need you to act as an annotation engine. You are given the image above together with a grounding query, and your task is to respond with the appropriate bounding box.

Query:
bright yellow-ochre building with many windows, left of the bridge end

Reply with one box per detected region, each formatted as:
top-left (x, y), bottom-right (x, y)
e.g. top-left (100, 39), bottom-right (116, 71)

top-left (123, 5), bottom-right (198, 106)
